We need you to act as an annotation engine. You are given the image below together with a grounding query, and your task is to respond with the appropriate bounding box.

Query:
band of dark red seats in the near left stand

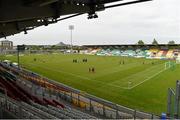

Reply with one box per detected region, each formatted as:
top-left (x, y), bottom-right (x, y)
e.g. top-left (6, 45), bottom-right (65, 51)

top-left (0, 64), bottom-right (95, 119)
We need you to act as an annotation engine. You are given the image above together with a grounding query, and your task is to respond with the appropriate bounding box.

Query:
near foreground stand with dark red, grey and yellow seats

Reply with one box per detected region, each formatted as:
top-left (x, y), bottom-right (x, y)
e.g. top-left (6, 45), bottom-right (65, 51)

top-left (0, 62), bottom-right (159, 119)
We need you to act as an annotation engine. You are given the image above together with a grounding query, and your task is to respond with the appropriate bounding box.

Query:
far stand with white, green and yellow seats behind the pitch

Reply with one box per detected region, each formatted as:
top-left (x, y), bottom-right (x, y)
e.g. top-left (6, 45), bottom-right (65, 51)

top-left (80, 44), bottom-right (180, 59)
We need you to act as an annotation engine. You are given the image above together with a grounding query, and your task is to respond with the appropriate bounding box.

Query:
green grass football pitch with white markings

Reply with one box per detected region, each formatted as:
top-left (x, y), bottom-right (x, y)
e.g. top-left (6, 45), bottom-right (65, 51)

top-left (5, 54), bottom-right (180, 114)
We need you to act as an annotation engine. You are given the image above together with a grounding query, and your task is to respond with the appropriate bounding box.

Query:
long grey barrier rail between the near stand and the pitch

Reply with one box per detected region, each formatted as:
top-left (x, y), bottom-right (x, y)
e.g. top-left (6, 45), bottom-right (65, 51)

top-left (1, 63), bottom-right (159, 119)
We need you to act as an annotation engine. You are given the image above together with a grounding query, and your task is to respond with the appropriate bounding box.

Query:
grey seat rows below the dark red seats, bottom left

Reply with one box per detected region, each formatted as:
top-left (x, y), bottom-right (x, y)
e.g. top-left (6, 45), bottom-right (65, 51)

top-left (0, 94), bottom-right (57, 119)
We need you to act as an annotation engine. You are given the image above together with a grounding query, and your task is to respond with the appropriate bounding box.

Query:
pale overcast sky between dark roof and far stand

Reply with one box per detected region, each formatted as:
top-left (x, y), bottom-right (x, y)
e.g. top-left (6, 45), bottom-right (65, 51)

top-left (0, 0), bottom-right (180, 45)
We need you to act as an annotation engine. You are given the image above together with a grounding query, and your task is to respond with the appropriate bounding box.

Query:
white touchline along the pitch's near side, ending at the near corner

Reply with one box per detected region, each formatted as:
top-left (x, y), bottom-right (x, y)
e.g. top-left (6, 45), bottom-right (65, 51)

top-left (23, 63), bottom-right (129, 89)
